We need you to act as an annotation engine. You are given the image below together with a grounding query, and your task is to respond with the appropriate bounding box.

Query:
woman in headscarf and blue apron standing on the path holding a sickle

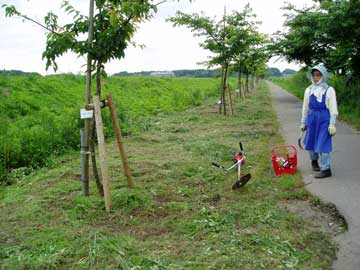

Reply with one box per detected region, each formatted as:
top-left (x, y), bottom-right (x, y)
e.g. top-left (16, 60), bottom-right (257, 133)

top-left (300, 65), bottom-right (338, 178)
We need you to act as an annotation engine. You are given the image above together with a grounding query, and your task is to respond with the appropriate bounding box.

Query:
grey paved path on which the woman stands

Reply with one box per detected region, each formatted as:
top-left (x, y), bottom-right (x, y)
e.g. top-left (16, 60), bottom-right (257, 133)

top-left (268, 82), bottom-right (360, 270)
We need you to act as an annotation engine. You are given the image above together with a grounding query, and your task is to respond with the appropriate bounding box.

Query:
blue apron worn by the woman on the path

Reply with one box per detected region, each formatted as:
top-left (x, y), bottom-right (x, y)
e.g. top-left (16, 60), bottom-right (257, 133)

top-left (304, 89), bottom-right (332, 153)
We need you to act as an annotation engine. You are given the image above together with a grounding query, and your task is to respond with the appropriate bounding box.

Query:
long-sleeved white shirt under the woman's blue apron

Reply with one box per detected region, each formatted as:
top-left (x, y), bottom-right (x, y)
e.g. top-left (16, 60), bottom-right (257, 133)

top-left (301, 85), bottom-right (339, 124)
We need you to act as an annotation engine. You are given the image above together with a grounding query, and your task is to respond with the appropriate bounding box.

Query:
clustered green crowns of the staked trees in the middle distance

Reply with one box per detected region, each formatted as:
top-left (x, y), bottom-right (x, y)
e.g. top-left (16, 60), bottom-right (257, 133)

top-left (169, 5), bottom-right (269, 114)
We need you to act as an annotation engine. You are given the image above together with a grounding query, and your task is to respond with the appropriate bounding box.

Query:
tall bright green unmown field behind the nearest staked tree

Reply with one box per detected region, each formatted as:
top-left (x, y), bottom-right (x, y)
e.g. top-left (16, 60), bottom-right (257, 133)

top-left (0, 75), bottom-right (218, 182)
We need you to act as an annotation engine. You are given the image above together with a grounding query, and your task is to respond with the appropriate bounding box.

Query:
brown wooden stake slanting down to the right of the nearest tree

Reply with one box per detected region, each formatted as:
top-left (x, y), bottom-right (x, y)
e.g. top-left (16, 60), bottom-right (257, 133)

top-left (106, 95), bottom-right (134, 188)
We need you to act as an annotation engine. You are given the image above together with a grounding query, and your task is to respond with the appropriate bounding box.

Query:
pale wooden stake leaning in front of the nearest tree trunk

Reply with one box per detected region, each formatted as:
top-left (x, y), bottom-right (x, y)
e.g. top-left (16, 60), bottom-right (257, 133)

top-left (94, 96), bottom-right (111, 212)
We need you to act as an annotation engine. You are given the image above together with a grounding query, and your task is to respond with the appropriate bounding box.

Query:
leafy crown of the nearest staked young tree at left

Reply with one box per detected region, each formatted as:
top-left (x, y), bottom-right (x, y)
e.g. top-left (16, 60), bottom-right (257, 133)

top-left (2, 0), bottom-right (186, 194)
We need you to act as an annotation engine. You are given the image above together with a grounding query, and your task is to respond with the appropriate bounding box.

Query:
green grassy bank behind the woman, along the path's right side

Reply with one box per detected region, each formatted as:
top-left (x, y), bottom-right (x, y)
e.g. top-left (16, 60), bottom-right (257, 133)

top-left (271, 71), bottom-right (360, 129)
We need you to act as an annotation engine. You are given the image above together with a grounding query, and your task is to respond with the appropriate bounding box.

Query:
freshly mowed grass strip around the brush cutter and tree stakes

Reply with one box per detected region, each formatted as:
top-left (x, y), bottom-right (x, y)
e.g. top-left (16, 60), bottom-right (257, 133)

top-left (0, 83), bottom-right (335, 270)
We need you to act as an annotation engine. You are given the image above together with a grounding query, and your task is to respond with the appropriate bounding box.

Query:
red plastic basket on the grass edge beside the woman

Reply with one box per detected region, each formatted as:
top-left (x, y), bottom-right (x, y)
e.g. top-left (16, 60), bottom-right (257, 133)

top-left (271, 145), bottom-right (297, 175)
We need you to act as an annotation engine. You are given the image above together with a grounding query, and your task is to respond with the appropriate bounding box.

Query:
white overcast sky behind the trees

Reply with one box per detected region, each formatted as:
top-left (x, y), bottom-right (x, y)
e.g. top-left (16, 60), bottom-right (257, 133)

top-left (0, 0), bottom-right (314, 75)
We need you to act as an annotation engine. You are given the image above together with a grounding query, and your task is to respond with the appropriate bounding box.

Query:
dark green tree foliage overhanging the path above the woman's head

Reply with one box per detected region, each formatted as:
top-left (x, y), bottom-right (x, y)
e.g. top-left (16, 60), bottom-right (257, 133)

top-left (271, 0), bottom-right (360, 78)
